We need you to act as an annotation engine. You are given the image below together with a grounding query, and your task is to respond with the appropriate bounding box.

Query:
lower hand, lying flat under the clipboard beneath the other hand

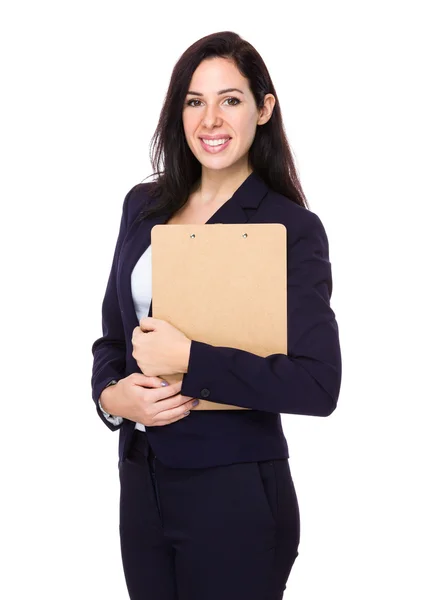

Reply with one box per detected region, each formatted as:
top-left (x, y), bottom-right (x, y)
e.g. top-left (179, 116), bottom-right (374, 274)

top-left (100, 373), bottom-right (198, 427)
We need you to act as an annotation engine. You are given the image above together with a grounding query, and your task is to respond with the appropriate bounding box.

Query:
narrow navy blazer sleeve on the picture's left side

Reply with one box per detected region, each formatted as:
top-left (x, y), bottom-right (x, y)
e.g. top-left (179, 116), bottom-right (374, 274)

top-left (91, 188), bottom-right (135, 431)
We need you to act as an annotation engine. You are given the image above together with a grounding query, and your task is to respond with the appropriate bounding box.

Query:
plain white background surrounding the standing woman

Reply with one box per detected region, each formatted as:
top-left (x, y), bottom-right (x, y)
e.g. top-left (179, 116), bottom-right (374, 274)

top-left (0, 0), bottom-right (428, 600)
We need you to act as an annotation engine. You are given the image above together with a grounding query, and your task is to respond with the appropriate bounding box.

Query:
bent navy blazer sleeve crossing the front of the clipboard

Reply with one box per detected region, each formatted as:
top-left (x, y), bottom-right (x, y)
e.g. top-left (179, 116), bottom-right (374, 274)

top-left (180, 210), bottom-right (342, 416)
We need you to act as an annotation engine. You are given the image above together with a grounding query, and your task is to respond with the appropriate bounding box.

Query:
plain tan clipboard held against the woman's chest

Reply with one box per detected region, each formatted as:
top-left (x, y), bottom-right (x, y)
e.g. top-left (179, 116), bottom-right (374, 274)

top-left (151, 223), bottom-right (287, 411)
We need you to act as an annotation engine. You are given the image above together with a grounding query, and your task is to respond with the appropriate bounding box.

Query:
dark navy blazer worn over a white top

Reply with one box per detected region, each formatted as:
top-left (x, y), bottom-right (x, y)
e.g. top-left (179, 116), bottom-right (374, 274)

top-left (91, 172), bottom-right (342, 468)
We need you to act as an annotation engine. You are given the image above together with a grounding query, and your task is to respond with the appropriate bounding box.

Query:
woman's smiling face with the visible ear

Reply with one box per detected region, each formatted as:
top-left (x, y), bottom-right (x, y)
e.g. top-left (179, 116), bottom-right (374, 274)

top-left (183, 57), bottom-right (275, 170)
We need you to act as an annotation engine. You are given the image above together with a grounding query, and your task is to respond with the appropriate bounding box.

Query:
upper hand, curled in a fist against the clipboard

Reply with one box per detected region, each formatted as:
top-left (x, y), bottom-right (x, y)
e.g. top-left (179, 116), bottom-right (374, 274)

top-left (132, 317), bottom-right (191, 377)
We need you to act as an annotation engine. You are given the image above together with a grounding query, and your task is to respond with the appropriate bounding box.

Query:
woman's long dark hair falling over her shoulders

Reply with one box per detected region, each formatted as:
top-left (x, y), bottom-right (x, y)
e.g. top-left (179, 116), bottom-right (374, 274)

top-left (135, 31), bottom-right (308, 219)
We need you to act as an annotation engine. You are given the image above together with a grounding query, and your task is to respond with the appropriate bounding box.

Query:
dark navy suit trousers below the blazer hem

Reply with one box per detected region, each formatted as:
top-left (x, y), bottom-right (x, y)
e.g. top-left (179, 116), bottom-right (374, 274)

top-left (119, 430), bottom-right (300, 600)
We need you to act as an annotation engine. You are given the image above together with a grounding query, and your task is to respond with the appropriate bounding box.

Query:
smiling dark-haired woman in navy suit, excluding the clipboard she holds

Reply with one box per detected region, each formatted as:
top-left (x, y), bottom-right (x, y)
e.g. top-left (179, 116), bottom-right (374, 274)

top-left (92, 31), bottom-right (341, 600)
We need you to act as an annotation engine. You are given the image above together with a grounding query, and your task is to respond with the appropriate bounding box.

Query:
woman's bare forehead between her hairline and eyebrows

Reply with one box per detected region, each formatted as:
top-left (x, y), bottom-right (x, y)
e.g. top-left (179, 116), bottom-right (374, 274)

top-left (189, 57), bottom-right (249, 93)
